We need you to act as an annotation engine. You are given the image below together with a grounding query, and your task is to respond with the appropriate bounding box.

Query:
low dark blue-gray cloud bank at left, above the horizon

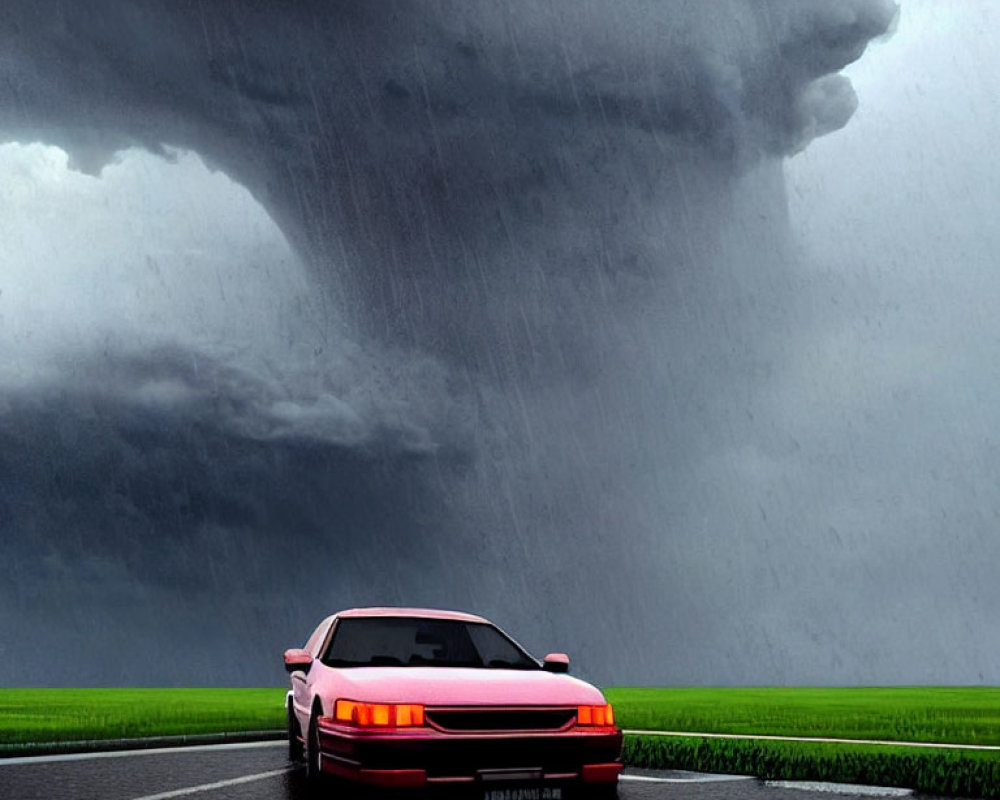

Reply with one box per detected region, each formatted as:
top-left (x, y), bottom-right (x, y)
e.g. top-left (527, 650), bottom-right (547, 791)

top-left (0, 342), bottom-right (480, 685)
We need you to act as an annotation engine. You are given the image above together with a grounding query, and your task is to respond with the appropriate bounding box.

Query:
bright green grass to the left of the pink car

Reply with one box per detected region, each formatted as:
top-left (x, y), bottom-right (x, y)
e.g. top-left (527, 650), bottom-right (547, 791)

top-left (0, 689), bottom-right (285, 754)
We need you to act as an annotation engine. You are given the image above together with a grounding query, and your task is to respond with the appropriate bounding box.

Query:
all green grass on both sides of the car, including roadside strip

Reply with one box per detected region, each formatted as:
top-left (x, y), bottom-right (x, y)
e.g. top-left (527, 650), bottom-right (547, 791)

top-left (0, 688), bottom-right (1000, 798)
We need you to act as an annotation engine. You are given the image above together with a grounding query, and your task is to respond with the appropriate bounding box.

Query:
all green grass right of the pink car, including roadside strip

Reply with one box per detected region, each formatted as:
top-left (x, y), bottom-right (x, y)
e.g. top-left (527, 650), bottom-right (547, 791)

top-left (605, 687), bottom-right (1000, 798)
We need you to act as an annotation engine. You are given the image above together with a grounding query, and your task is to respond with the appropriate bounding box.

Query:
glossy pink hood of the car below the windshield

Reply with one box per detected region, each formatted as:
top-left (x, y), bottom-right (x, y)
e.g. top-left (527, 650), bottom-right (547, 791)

top-left (322, 667), bottom-right (605, 705)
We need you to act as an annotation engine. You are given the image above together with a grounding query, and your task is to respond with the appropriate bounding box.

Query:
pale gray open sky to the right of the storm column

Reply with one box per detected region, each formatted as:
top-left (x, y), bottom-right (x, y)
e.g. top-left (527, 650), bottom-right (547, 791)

top-left (775, 0), bottom-right (1000, 682)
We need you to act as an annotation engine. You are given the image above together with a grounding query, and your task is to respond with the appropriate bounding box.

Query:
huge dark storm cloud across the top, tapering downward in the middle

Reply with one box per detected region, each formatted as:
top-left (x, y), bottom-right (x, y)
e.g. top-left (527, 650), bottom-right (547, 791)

top-left (0, 0), bottom-right (895, 282)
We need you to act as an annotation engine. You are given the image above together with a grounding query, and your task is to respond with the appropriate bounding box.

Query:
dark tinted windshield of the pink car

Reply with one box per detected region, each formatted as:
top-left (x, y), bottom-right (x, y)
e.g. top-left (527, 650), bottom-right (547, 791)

top-left (323, 617), bottom-right (541, 669)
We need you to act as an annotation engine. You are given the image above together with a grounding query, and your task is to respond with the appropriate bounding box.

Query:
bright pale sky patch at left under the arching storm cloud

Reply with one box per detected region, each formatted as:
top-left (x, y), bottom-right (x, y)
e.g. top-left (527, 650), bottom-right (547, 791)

top-left (0, 144), bottom-right (306, 382)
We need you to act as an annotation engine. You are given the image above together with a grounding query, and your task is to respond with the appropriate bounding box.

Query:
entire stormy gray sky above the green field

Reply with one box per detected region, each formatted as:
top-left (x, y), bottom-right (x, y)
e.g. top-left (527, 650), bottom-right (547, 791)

top-left (0, 0), bottom-right (1000, 684)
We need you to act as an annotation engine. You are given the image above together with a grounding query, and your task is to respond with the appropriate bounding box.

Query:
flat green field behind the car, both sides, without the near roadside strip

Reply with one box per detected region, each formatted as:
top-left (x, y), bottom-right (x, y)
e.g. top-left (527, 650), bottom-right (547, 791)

top-left (0, 688), bottom-right (1000, 745)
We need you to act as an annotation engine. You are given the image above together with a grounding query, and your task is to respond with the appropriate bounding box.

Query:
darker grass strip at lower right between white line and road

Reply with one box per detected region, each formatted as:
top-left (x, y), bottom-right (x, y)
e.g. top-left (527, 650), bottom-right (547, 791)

top-left (625, 736), bottom-right (1000, 799)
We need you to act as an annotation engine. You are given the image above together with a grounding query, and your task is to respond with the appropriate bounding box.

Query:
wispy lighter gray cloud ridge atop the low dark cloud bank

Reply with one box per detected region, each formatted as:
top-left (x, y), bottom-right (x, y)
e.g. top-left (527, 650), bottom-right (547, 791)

top-left (31, 345), bottom-right (469, 454)
